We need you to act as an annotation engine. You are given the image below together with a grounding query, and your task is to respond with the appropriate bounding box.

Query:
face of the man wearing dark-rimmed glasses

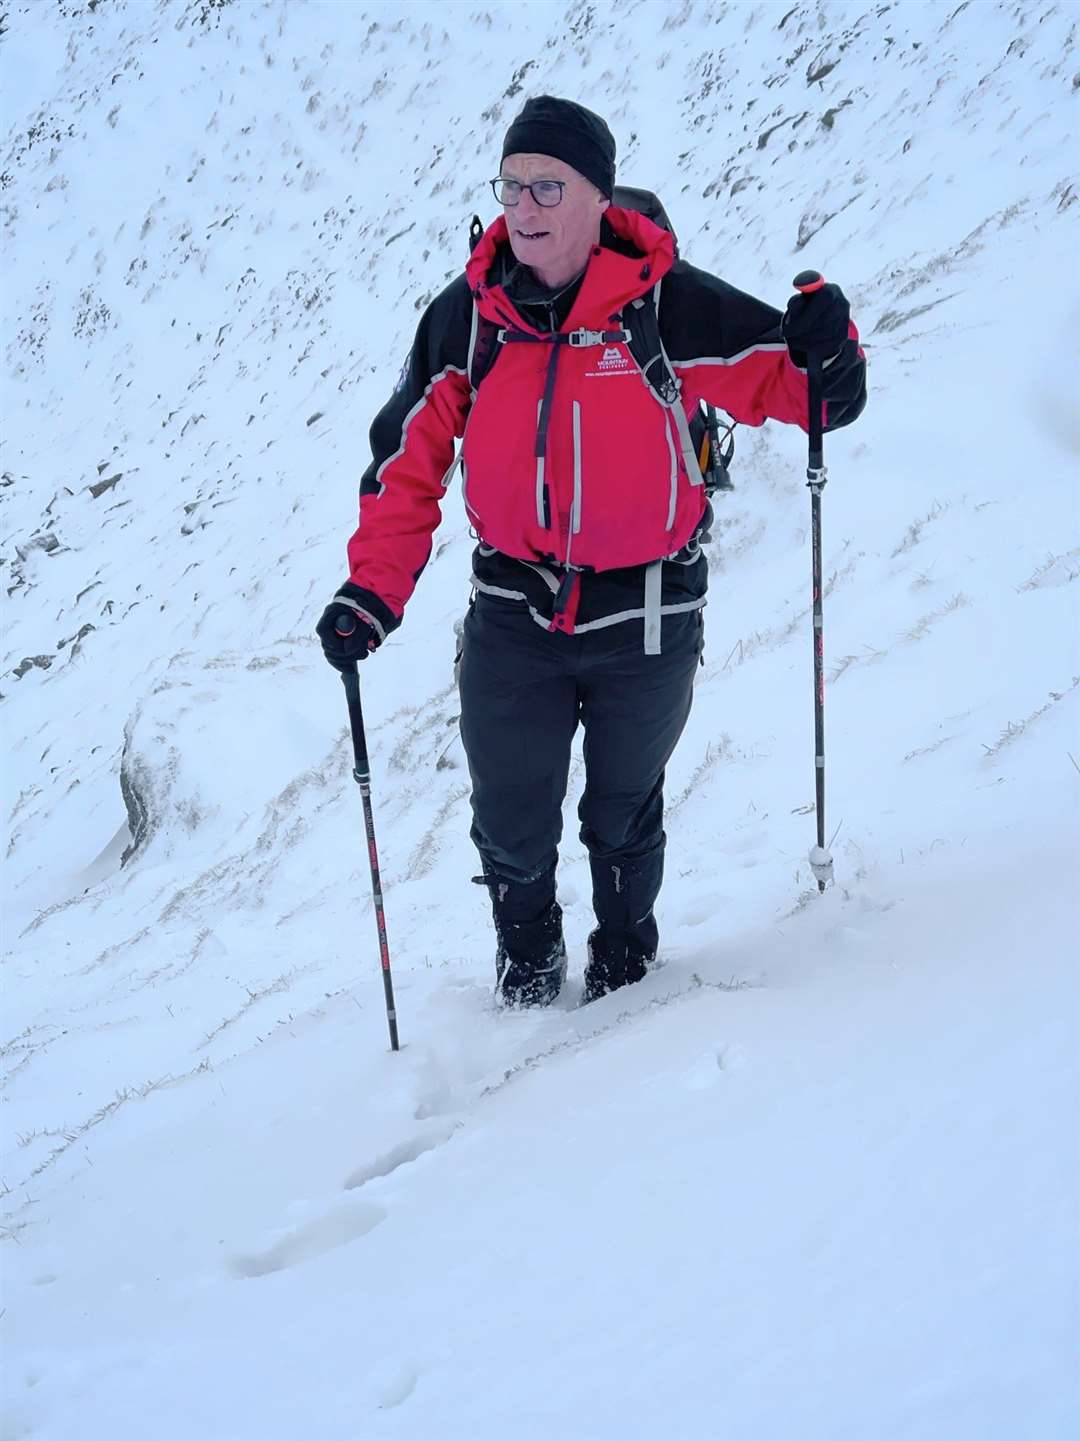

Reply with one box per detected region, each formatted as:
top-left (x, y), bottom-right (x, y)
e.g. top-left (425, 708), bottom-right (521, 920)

top-left (499, 156), bottom-right (610, 284)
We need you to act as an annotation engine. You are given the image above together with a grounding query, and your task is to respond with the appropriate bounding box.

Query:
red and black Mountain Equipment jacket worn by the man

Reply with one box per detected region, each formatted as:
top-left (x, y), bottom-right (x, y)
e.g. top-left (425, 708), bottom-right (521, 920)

top-left (349, 206), bottom-right (867, 633)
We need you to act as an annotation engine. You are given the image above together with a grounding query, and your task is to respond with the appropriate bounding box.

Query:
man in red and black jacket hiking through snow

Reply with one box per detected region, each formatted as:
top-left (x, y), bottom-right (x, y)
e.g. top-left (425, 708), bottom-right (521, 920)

top-left (317, 95), bottom-right (865, 1004)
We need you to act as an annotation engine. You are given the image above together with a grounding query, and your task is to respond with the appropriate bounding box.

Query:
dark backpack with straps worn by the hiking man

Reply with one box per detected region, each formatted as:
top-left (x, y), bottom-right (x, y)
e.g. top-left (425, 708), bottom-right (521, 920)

top-left (469, 186), bottom-right (735, 495)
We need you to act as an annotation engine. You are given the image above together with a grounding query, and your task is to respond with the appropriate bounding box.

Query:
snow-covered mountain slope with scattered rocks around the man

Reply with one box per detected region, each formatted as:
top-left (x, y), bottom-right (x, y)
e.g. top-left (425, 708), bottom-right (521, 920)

top-left (0, 0), bottom-right (1080, 1441)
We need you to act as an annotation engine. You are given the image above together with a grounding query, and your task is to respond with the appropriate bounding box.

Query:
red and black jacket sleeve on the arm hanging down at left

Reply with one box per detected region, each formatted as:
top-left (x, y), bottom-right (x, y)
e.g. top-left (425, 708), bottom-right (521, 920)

top-left (338, 280), bottom-right (472, 633)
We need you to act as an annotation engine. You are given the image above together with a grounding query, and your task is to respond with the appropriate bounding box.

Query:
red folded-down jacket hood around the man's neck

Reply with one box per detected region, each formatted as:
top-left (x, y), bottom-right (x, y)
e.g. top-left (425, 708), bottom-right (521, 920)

top-left (466, 205), bottom-right (675, 318)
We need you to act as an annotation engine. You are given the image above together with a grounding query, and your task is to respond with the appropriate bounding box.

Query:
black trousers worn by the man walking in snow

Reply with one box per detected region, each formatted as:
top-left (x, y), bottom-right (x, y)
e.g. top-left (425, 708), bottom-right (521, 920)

top-left (459, 595), bottom-right (704, 961)
